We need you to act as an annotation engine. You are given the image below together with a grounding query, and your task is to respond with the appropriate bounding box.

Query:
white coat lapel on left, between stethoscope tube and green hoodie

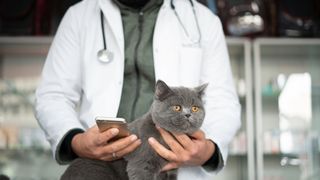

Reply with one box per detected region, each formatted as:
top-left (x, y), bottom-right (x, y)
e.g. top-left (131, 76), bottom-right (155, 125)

top-left (99, 0), bottom-right (124, 55)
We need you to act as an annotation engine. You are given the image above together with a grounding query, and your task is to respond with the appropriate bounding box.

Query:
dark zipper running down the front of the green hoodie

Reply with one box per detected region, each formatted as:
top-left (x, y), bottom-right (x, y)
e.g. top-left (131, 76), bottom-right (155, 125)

top-left (130, 11), bottom-right (144, 120)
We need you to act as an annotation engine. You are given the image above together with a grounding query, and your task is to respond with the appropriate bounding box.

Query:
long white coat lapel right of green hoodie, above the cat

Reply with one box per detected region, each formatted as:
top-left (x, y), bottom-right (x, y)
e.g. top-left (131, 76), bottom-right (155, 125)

top-left (153, 0), bottom-right (180, 86)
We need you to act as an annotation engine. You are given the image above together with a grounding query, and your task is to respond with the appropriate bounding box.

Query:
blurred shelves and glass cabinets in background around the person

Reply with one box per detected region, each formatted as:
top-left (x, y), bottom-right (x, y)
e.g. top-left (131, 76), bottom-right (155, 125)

top-left (0, 0), bottom-right (320, 180)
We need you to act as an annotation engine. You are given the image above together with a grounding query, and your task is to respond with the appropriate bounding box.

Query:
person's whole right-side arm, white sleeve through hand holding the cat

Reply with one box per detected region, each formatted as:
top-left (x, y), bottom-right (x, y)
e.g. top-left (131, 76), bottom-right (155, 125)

top-left (149, 7), bottom-right (240, 172)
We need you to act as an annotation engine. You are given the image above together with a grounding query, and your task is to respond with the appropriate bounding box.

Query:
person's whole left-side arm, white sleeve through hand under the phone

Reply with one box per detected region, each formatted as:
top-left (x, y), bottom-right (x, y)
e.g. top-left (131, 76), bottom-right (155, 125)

top-left (35, 4), bottom-right (141, 164)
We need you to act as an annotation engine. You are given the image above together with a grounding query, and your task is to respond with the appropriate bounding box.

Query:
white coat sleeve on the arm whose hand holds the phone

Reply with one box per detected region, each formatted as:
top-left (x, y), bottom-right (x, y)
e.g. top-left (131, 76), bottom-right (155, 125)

top-left (35, 8), bottom-right (83, 163)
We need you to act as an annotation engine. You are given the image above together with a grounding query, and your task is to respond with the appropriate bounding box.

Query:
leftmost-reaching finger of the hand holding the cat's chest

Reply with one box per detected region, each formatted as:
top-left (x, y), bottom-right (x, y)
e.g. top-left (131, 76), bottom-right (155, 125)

top-left (148, 137), bottom-right (178, 161)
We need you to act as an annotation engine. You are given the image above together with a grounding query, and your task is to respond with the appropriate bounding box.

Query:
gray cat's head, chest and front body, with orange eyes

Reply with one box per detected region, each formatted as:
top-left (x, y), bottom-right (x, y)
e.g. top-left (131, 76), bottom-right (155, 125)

top-left (125, 80), bottom-right (207, 180)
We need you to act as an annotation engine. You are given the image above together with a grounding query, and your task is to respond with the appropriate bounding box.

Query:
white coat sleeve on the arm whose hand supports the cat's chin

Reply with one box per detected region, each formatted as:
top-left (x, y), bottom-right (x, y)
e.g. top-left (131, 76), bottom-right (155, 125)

top-left (201, 15), bottom-right (241, 171)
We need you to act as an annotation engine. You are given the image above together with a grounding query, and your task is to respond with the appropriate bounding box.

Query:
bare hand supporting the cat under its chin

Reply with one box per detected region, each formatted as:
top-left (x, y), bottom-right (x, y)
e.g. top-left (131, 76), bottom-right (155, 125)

top-left (148, 127), bottom-right (215, 171)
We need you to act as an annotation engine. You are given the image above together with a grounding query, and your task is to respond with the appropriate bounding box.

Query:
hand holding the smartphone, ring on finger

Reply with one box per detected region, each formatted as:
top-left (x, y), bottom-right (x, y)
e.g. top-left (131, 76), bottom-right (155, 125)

top-left (71, 125), bottom-right (141, 161)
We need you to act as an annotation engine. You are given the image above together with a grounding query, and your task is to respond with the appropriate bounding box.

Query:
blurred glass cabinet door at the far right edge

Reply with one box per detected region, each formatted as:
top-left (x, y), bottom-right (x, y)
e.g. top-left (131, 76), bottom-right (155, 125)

top-left (254, 39), bottom-right (320, 180)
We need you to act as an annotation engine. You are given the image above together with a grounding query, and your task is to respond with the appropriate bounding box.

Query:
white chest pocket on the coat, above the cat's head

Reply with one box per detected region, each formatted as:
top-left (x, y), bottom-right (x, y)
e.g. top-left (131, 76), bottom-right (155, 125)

top-left (179, 46), bottom-right (202, 87)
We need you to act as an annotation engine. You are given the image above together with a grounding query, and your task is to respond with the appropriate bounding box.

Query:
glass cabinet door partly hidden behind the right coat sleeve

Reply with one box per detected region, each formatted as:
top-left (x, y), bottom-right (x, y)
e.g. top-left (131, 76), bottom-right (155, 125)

top-left (215, 38), bottom-right (254, 180)
